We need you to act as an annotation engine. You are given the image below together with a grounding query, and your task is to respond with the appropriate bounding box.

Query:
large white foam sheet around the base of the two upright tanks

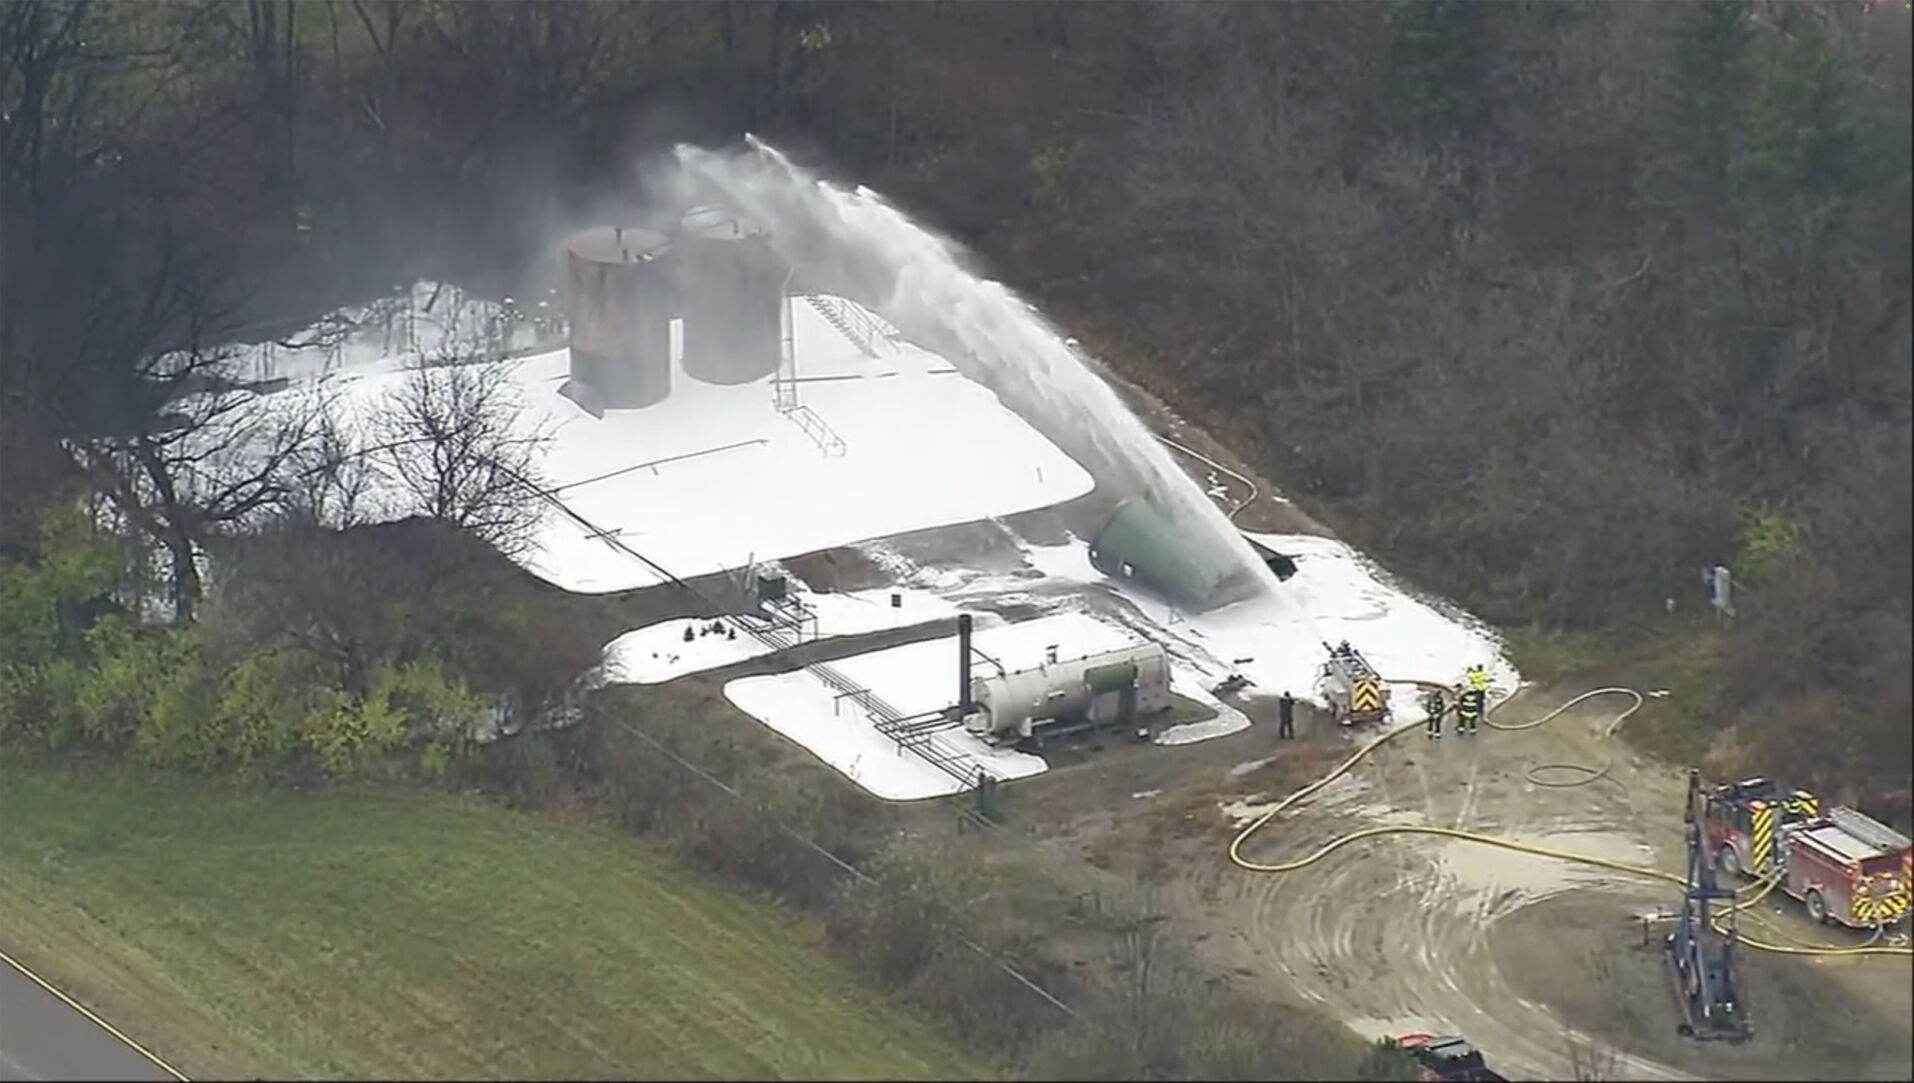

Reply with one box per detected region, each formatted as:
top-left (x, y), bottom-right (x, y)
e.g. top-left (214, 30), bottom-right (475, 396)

top-left (227, 290), bottom-right (1093, 593)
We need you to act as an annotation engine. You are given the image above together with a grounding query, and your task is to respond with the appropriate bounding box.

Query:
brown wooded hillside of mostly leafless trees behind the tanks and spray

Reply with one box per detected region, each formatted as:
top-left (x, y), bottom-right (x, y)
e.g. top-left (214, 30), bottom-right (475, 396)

top-left (0, 0), bottom-right (1914, 817)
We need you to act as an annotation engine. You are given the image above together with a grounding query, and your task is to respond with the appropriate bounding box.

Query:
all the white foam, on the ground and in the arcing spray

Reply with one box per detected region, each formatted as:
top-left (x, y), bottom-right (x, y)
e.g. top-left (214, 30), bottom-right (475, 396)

top-left (190, 159), bottom-right (1518, 800)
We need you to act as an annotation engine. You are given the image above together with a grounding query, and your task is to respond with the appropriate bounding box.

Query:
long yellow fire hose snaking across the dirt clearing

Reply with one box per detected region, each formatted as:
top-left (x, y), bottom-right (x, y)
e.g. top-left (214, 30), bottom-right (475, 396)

top-left (1229, 681), bottom-right (1914, 957)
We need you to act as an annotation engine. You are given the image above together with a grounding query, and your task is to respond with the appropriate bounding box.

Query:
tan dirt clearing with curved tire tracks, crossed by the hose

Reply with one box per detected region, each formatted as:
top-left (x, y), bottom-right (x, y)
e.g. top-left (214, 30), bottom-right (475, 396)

top-left (1210, 695), bottom-right (1910, 1079)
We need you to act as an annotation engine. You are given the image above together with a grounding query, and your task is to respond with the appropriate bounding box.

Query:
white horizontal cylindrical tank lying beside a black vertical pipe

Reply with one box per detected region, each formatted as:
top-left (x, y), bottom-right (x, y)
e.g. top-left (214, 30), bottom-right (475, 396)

top-left (970, 643), bottom-right (1169, 737)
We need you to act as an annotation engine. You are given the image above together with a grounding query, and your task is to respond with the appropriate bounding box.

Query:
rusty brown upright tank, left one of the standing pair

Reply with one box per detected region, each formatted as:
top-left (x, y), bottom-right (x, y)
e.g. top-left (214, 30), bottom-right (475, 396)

top-left (565, 226), bottom-right (674, 409)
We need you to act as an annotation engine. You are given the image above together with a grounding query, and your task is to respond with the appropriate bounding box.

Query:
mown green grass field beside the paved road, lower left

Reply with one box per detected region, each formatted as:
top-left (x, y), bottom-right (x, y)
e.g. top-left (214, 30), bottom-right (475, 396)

top-left (0, 763), bottom-right (982, 1079)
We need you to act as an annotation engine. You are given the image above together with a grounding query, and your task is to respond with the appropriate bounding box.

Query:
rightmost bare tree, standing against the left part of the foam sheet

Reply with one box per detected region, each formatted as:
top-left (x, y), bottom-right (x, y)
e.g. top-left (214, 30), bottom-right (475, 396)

top-left (375, 350), bottom-right (549, 557)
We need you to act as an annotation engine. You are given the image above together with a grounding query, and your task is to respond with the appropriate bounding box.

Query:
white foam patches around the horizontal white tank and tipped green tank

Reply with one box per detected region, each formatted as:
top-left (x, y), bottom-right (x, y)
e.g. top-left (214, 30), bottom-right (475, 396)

top-left (624, 516), bottom-right (1518, 800)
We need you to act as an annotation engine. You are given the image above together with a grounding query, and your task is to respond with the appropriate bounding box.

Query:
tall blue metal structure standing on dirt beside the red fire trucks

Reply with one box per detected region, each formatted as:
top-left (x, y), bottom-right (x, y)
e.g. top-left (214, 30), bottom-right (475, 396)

top-left (1663, 771), bottom-right (1753, 1043)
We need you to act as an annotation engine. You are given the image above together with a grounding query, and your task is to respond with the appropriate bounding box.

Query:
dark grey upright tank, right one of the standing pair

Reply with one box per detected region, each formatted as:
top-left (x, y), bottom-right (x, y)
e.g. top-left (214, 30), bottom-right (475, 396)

top-left (676, 209), bottom-right (789, 385)
